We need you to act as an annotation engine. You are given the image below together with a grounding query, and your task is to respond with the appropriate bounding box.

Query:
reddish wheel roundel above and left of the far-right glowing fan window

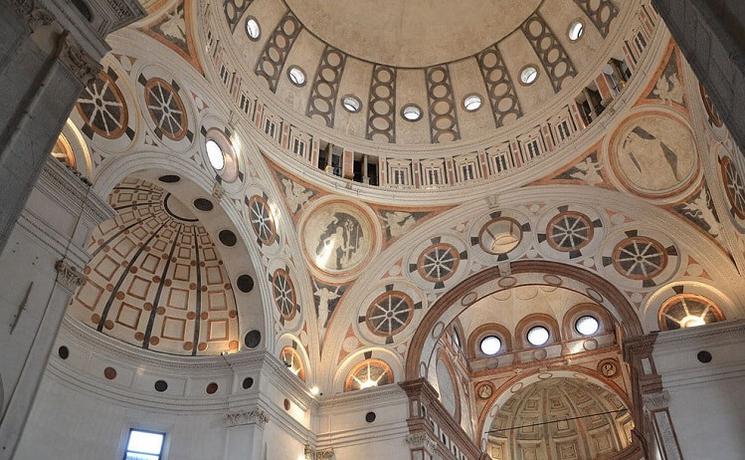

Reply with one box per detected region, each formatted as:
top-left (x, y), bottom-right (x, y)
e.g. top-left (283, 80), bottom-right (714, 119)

top-left (613, 236), bottom-right (667, 280)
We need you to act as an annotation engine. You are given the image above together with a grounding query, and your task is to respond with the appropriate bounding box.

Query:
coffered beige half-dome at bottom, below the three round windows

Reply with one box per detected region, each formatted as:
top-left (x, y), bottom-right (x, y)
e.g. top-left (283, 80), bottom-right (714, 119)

top-left (489, 377), bottom-right (633, 459)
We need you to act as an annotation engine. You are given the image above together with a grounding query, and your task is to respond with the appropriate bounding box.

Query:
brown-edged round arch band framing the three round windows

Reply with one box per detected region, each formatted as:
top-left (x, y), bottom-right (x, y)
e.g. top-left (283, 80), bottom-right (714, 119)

top-left (405, 260), bottom-right (644, 380)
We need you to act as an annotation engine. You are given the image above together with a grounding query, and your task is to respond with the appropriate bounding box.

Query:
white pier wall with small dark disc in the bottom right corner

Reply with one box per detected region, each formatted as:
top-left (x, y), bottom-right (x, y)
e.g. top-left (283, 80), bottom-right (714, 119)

top-left (653, 321), bottom-right (745, 460)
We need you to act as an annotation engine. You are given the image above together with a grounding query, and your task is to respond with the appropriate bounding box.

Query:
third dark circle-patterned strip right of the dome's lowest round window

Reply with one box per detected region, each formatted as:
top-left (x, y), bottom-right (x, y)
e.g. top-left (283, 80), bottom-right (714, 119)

top-left (522, 13), bottom-right (577, 93)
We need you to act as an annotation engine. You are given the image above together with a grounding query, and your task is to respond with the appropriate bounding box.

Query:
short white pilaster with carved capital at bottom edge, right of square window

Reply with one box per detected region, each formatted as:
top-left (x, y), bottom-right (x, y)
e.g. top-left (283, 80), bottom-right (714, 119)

top-left (224, 408), bottom-right (269, 460)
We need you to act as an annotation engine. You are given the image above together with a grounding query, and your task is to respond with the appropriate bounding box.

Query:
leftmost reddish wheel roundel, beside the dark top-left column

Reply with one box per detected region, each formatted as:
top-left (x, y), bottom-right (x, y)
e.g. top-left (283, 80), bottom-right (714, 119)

top-left (77, 73), bottom-right (129, 139)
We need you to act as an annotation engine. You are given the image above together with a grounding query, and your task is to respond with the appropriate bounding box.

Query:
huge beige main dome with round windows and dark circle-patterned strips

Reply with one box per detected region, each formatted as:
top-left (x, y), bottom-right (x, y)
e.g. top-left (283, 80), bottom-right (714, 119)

top-left (202, 0), bottom-right (628, 146)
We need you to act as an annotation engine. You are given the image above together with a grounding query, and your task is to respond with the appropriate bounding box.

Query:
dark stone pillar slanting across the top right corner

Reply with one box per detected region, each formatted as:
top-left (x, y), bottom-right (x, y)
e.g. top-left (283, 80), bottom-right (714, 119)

top-left (652, 0), bottom-right (745, 154)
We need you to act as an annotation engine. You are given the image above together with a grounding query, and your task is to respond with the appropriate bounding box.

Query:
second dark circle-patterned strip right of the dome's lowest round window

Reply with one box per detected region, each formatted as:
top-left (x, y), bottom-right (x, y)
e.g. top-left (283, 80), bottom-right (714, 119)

top-left (476, 45), bottom-right (523, 128)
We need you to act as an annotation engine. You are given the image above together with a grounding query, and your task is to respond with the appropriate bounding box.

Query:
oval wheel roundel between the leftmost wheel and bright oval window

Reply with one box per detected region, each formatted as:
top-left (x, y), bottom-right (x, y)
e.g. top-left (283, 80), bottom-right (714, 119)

top-left (145, 78), bottom-right (188, 141)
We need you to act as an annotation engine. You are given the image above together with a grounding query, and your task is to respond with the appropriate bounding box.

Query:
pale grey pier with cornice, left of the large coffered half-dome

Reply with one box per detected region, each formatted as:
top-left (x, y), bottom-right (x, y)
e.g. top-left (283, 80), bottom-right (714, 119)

top-left (0, 157), bottom-right (114, 460)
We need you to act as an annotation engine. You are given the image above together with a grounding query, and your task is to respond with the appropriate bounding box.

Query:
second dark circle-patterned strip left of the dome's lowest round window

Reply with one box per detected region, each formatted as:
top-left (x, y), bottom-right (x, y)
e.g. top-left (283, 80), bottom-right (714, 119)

top-left (306, 46), bottom-right (347, 128)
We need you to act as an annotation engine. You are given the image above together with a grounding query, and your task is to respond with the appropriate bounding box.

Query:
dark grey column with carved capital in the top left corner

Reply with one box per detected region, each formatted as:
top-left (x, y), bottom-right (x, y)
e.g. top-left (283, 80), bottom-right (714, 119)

top-left (0, 0), bottom-right (144, 252)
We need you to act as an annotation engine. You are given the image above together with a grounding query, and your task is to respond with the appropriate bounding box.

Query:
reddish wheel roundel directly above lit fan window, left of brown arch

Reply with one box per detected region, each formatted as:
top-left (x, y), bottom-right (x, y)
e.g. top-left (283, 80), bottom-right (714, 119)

top-left (365, 291), bottom-right (414, 337)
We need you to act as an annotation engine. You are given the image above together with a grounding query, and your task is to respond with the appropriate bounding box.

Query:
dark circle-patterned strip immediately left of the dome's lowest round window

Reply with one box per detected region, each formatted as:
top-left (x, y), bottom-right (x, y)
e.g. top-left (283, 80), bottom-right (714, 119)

top-left (367, 64), bottom-right (396, 143)
